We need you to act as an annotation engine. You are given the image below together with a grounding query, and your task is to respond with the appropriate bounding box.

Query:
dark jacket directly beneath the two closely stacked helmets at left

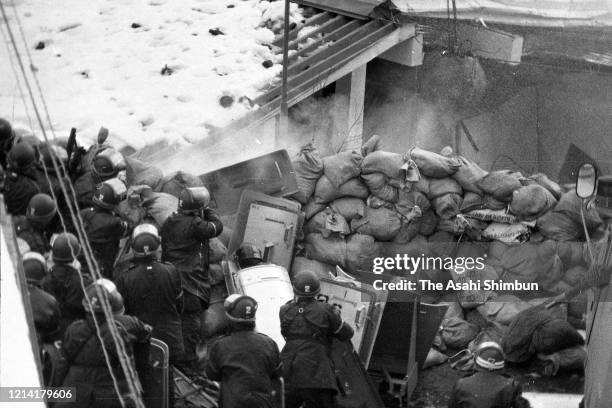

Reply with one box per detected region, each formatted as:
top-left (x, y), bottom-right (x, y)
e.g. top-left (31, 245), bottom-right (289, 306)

top-left (81, 207), bottom-right (128, 279)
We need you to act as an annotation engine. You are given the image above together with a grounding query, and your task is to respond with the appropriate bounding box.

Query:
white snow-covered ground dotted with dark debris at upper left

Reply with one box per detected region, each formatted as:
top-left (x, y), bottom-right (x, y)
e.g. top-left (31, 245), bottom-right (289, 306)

top-left (0, 0), bottom-right (302, 149)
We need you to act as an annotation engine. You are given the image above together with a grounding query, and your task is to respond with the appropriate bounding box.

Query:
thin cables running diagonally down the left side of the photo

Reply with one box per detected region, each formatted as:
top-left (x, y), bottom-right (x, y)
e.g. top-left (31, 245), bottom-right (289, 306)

top-left (0, 3), bottom-right (143, 406)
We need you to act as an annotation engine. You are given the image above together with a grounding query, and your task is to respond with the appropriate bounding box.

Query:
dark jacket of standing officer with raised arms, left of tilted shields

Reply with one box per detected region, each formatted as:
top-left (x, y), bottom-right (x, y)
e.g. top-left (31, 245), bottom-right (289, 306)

top-left (161, 209), bottom-right (223, 302)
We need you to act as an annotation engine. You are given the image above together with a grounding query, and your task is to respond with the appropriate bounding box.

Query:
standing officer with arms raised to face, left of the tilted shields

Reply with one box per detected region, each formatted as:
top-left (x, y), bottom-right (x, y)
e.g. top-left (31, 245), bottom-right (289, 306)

top-left (161, 187), bottom-right (223, 371)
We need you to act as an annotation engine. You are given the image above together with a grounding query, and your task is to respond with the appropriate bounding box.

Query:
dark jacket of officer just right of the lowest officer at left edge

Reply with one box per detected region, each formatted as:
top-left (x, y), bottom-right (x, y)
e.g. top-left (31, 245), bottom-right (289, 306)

top-left (43, 263), bottom-right (92, 333)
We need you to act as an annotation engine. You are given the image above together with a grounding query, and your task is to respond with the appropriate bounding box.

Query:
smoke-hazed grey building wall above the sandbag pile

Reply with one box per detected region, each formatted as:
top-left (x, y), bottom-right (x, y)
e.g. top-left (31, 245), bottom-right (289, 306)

top-left (364, 52), bottom-right (612, 178)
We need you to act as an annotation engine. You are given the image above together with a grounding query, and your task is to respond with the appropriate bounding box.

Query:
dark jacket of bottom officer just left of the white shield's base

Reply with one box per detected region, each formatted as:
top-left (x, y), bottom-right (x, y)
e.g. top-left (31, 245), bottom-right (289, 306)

top-left (206, 330), bottom-right (280, 408)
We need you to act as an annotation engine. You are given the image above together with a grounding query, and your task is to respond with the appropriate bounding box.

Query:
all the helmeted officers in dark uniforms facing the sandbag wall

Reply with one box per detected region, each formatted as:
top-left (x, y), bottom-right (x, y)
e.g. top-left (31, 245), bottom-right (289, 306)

top-left (0, 115), bottom-right (526, 408)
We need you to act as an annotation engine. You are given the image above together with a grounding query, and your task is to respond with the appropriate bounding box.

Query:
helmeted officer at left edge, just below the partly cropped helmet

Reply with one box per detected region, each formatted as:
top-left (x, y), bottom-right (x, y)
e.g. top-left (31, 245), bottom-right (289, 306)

top-left (4, 142), bottom-right (40, 215)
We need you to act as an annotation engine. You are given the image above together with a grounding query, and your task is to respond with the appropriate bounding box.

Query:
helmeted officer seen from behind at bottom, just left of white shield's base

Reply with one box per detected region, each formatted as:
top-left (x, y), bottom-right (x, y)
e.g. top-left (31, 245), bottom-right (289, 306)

top-left (205, 295), bottom-right (280, 408)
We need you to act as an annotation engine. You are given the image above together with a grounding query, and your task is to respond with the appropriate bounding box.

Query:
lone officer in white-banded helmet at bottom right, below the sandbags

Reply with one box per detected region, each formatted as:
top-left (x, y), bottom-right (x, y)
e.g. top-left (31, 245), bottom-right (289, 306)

top-left (448, 341), bottom-right (530, 408)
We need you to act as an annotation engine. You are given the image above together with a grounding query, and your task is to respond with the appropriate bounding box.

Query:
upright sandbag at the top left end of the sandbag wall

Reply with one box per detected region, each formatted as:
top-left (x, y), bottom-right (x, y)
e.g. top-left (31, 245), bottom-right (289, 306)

top-left (292, 143), bottom-right (323, 204)
